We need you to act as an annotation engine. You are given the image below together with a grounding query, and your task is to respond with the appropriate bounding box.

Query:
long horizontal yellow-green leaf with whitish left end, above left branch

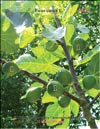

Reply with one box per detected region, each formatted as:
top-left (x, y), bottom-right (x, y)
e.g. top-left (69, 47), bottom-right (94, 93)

top-left (16, 54), bottom-right (59, 74)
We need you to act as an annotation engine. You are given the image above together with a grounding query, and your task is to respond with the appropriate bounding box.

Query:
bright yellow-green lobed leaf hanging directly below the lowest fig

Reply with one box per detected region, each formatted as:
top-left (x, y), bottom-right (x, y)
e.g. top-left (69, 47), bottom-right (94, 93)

top-left (45, 102), bottom-right (71, 128)
